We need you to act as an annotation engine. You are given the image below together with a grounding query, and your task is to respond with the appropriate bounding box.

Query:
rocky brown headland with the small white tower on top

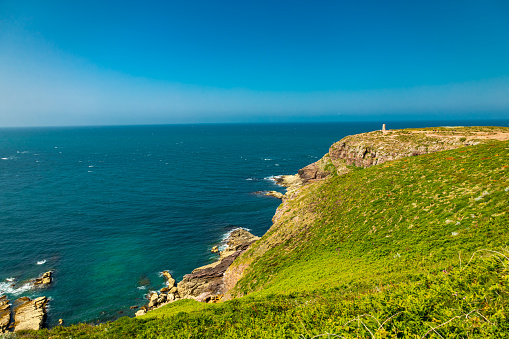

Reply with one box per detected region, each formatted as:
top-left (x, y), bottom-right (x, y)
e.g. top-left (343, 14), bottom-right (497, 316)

top-left (275, 127), bottom-right (509, 187)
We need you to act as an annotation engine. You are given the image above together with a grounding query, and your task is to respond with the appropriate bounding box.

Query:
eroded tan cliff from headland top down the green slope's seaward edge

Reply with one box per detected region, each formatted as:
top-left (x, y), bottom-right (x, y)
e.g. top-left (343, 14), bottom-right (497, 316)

top-left (224, 127), bottom-right (509, 299)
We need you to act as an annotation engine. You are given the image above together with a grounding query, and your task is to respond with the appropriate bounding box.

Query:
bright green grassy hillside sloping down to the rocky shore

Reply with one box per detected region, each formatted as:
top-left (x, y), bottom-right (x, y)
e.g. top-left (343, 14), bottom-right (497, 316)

top-left (16, 142), bottom-right (509, 338)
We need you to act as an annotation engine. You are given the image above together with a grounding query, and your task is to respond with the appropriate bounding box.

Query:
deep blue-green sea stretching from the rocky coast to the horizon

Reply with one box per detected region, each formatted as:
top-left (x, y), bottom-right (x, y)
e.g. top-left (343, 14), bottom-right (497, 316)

top-left (0, 121), bottom-right (509, 326)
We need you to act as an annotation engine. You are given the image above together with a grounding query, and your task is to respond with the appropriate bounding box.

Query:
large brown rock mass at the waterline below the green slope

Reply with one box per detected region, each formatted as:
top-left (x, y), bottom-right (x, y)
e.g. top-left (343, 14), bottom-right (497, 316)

top-left (177, 229), bottom-right (259, 302)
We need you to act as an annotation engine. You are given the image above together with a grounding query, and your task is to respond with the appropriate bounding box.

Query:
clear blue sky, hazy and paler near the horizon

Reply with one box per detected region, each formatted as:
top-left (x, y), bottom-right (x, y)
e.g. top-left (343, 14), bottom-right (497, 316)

top-left (0, 0), bottom-right (509, 127)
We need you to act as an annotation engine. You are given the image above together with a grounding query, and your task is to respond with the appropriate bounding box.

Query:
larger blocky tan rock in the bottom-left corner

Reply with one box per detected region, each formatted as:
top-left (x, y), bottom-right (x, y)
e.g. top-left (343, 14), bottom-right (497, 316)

top-left (14, 297), bottom-right (48, 332)
